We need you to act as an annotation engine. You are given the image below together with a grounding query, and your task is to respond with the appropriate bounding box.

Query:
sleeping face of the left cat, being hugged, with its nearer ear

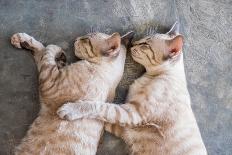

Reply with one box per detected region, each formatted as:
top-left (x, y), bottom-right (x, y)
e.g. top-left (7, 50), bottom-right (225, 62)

top-left (74, 33), bottom-right (121, 62)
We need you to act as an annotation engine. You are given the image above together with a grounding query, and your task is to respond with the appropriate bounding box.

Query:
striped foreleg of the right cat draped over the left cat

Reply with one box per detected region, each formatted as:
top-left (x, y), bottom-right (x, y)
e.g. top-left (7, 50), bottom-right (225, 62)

top-left (57, 101), bottom-right (145, 126)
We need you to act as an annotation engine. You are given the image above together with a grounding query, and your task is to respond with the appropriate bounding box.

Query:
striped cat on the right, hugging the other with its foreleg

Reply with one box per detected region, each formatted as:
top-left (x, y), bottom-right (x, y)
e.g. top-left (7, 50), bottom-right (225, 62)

top-left (58, 23), bottom-right (207, 155)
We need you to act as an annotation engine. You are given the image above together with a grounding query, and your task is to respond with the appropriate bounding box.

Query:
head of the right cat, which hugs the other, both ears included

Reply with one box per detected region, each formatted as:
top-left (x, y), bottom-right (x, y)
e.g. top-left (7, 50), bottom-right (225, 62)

top-left (131, 22), bottom-right (183, 69)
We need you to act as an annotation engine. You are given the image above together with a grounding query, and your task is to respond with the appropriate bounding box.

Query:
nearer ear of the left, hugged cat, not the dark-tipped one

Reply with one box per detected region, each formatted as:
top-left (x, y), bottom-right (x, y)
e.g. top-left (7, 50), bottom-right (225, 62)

top-left (102, 32), bottom-right (121, 57)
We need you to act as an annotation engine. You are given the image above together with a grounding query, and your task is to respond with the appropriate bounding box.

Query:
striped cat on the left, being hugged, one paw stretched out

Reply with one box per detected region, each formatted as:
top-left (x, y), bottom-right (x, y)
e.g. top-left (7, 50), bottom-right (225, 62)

top-left (11, 32), bottom-right (133, 155)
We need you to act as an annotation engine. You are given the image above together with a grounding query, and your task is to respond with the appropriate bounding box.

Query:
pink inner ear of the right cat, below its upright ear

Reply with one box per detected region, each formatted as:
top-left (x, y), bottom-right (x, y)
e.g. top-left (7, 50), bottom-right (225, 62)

top-left (166, 35), bottom-right (183, 58)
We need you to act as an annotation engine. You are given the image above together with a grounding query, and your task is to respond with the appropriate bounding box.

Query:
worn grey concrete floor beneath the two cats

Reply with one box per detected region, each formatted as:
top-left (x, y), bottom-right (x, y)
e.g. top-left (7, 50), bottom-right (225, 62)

top-left (0, 0), bottom-right (232, 155)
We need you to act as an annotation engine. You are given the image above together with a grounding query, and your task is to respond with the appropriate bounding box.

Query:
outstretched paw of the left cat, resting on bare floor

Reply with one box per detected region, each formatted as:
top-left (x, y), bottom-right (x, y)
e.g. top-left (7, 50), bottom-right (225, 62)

top-left (11, 33), bottom-right (33, 49)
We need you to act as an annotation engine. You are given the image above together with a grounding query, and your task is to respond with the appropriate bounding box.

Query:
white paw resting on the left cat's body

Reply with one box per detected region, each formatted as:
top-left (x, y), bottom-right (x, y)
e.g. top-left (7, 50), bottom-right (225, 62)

top-left (57, 103), bottom-right (78, 121)
